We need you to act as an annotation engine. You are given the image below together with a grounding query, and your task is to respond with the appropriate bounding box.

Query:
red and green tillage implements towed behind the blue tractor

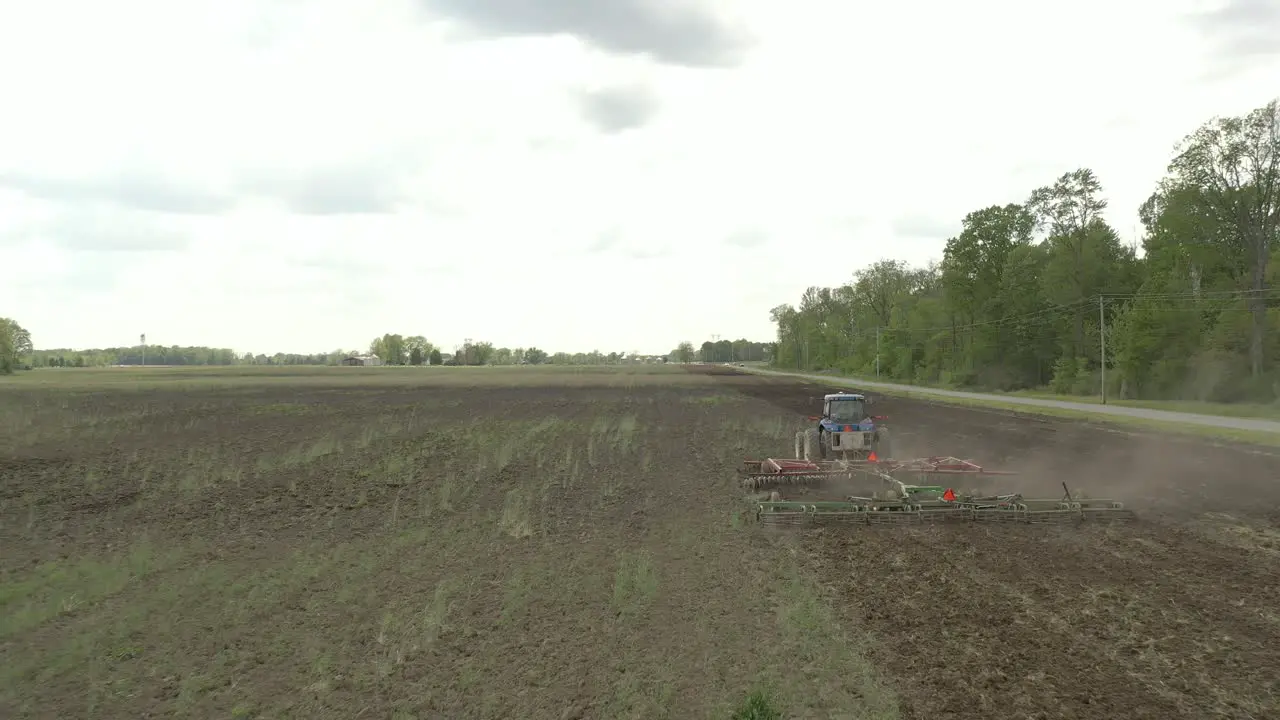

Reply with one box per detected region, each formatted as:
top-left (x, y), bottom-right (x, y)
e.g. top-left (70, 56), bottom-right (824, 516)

top-left (741, 457), bottom-right (1137, 524)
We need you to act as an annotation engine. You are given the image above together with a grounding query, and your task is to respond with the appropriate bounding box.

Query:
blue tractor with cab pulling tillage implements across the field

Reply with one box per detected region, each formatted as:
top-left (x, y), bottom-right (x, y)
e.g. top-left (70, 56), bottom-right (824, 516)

top-left (795, 392), bottom-right (893, 462)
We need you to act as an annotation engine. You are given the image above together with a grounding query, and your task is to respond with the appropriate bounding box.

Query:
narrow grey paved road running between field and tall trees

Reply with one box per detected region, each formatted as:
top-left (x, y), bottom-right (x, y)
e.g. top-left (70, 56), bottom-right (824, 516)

top-left (742, 368), bottom-right (1280, 433)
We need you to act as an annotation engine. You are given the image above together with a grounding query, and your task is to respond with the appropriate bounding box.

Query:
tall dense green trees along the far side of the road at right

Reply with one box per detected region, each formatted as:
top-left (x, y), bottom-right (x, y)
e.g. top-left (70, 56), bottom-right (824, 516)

top-left (771, 100), bottom-right (1280, 402)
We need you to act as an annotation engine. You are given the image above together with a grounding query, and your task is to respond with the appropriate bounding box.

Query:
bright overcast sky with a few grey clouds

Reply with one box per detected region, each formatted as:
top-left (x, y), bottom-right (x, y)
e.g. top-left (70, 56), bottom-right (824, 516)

top-left (0, 0), bottom-right (1280, 352)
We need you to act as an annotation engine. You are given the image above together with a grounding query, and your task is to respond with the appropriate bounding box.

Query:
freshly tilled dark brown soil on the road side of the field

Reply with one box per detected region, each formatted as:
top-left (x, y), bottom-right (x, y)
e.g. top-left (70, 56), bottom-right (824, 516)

top-left (694, 366), bottom-right (1280, 719)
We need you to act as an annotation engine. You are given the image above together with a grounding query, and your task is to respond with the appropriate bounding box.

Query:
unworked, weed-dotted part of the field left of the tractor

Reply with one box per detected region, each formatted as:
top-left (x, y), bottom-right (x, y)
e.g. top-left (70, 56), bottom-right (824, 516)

top-left (0, 369), bottom-right (893, 719)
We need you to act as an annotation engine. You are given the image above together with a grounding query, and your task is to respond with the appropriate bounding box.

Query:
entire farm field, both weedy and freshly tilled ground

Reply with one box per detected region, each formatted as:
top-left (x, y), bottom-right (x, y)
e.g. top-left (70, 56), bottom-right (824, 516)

top-left (0, 368), bottom-right (1280, 719)
